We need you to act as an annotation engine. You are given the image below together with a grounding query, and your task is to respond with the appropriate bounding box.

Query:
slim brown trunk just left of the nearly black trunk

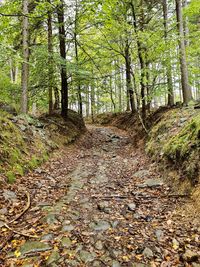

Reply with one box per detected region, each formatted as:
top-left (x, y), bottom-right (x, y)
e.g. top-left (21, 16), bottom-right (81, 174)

top-left (48, 0), bottom-right (54, 114)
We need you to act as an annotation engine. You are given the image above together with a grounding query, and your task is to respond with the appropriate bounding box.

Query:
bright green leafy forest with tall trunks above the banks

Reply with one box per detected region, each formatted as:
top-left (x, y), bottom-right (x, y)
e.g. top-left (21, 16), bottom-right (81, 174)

top-left (0, 0), bottom-right (200, 120)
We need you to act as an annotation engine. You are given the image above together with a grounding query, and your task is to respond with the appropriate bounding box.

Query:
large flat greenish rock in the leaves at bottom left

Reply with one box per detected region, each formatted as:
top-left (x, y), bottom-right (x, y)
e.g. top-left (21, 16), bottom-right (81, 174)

top-left (20, 241), bottom-right (51, 255)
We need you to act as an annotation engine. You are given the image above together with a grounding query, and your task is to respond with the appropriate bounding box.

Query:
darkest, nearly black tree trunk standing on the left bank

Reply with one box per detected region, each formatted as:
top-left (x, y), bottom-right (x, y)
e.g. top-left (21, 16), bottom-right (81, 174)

top-left (57, 0), bottom-right (69, 118)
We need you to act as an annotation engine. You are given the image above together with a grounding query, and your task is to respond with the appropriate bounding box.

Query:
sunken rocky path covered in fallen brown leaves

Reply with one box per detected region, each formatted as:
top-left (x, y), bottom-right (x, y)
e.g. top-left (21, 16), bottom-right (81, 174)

top-left (0, 126), bottom-right (200, 267)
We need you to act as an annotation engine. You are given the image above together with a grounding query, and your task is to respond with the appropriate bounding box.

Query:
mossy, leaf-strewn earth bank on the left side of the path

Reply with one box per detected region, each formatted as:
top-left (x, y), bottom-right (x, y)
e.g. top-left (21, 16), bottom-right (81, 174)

top-left (0, 110), bottom-right (85, 183)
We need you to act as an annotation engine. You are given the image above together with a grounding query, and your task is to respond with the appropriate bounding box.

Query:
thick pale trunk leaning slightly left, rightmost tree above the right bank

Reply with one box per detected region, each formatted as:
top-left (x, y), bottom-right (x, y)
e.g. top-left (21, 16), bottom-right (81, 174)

top-left (176, 0), bottom-right (192, 105)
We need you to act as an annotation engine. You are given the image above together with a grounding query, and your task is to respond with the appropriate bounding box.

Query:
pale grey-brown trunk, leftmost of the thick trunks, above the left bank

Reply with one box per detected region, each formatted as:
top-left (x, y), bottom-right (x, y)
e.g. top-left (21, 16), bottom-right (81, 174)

top-left (21, 0), bottom-right (29, 113)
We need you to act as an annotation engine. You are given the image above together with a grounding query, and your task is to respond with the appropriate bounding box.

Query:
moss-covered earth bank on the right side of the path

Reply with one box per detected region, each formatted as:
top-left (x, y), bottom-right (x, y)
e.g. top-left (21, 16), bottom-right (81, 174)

top-left (146, 109), bottom-right (200, 185)
